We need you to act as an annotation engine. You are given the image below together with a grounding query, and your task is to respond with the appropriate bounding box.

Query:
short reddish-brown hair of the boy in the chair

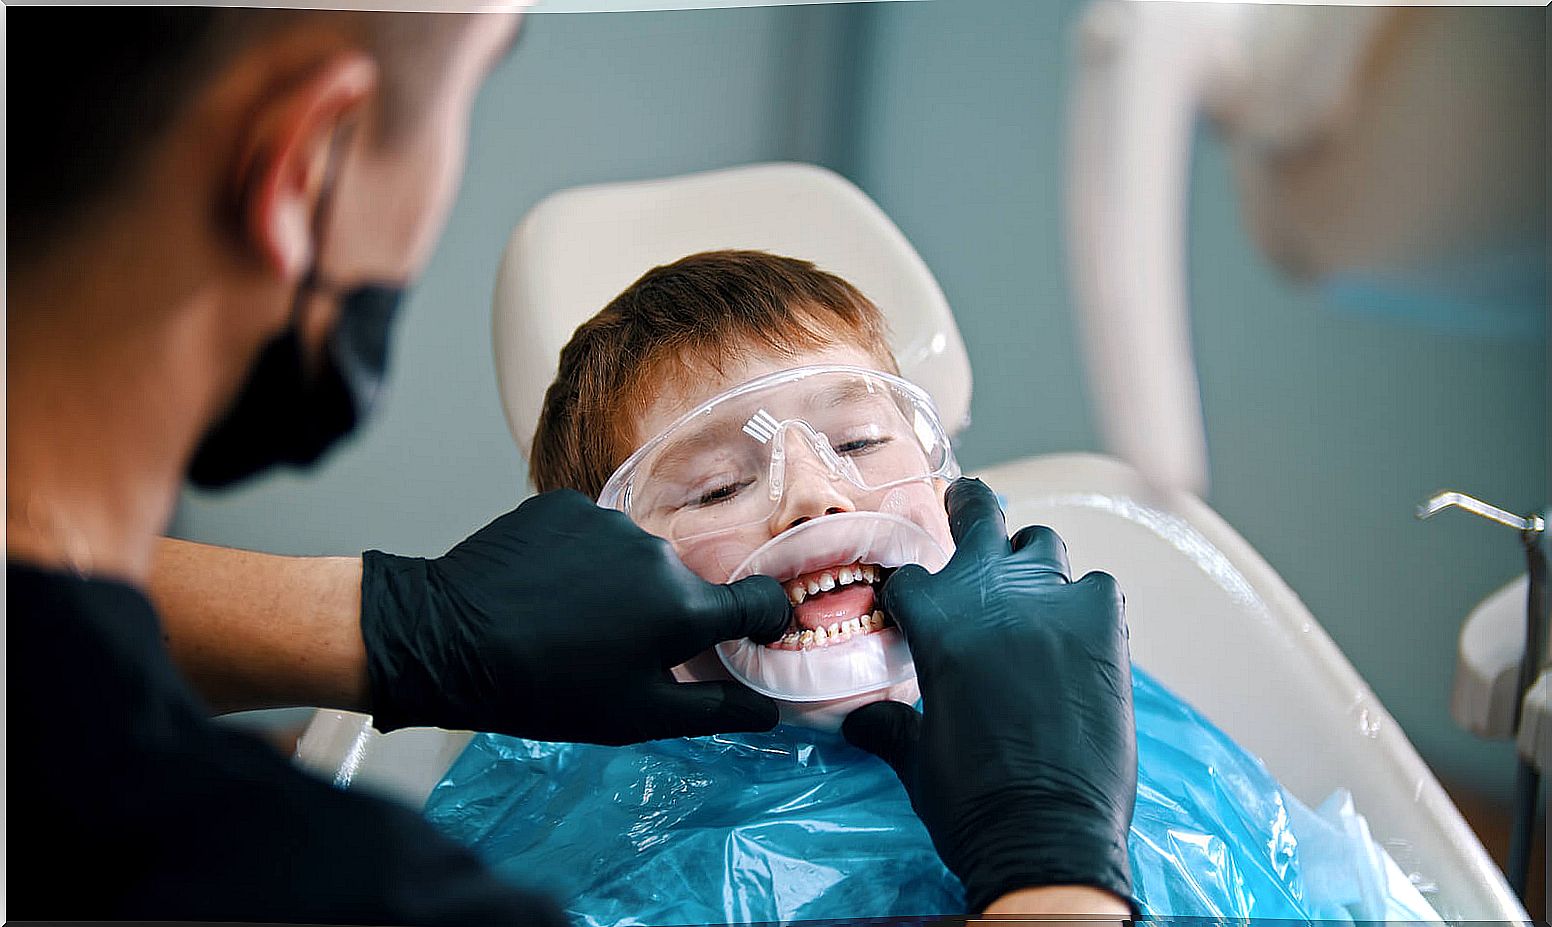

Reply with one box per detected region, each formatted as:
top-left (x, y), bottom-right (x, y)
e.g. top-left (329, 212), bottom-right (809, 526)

top-left (528, 250), bottom-right (899, 498)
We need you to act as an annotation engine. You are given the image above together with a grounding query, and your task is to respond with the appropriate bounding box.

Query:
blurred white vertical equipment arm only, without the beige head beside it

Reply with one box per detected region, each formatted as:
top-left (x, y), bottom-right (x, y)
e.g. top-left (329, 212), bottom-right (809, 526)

top-left (1066, 2), bottom-right (1234, 494)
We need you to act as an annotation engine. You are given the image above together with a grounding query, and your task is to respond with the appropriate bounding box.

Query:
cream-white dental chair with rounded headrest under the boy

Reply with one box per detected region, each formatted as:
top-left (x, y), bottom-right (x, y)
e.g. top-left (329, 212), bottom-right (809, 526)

top-left (296, 163), bottom-right (1527, 921)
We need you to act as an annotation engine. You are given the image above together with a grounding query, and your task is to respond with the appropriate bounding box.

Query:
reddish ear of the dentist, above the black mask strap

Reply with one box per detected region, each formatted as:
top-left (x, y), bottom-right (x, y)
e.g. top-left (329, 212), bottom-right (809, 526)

top-left (233, 51), bottom-right (379, 283)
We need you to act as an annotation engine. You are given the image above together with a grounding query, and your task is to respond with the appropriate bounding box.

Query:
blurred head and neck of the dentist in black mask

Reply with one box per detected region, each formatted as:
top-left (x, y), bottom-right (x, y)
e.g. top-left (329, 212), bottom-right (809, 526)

top-left (6, 8), bottom-right (518, 571)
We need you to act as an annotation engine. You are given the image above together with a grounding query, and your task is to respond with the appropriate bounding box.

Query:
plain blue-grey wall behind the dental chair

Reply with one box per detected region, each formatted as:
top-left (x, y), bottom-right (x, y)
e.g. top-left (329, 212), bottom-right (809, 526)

top-left (175, 0), bottom-right (1549, 793)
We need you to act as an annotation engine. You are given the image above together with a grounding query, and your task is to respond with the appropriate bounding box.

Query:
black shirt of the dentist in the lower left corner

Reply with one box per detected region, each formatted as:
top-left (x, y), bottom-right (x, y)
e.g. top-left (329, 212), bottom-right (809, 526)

top-left (6, 562), bottom-right (565, 925)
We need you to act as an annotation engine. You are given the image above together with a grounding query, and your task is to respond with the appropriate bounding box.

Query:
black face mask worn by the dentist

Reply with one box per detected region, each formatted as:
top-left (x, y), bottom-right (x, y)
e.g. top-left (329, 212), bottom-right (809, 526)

top-left (188, 130), bottom-right (404, 489)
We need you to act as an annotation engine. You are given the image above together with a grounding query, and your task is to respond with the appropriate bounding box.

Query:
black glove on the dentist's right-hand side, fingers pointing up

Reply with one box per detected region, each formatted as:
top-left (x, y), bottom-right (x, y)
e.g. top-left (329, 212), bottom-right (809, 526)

top-left (843, 480), bottom-right (1138, 913)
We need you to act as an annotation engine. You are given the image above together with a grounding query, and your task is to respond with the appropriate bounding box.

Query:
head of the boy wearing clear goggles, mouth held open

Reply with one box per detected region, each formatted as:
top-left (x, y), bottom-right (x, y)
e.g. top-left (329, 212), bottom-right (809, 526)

top-left (529, 252), bottom-right (958, 730)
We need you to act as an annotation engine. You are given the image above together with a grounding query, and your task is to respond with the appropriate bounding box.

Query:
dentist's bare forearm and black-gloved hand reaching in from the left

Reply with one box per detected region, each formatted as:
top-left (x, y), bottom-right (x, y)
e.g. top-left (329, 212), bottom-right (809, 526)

top-left (151, 491), bottom-right (790, 744)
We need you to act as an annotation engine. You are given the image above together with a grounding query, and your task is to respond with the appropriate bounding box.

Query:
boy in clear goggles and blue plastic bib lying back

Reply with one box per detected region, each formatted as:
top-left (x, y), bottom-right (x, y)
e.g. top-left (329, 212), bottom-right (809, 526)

top-left (425, 252), bottom-right (1426, 924)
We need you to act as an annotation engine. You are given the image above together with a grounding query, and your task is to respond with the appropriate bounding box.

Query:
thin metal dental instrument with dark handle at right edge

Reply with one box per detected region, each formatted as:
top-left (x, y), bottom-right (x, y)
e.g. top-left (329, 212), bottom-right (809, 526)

top-left (1417, 491), bottom-right (1549, 901)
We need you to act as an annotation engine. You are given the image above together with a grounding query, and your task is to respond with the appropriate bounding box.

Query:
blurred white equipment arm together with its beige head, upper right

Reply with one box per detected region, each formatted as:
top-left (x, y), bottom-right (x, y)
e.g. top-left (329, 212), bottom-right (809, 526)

top-left (1066, 0), bottom-right (1546, 495)
